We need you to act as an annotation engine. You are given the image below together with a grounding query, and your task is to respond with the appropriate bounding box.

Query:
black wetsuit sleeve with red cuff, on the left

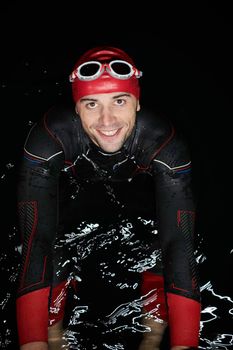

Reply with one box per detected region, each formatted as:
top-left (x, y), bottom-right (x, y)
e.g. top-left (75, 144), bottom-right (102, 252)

top-left (16, 116), bottom-right (64, 345)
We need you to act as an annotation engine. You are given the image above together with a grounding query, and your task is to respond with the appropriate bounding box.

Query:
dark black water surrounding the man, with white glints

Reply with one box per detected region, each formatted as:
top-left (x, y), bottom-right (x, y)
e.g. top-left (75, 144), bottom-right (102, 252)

top-left (0, 1), bottom-right (233, 350)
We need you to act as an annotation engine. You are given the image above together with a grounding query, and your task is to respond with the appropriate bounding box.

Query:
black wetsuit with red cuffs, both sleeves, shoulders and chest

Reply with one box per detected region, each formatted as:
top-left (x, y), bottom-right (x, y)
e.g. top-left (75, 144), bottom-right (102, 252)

top-left (17, 106), bottom-right (200, 346)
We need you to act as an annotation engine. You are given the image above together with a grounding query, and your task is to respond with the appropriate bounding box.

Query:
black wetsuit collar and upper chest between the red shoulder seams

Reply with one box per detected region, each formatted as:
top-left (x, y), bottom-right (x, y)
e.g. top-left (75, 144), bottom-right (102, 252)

top-left (47, 104), bottom-right (171, 182)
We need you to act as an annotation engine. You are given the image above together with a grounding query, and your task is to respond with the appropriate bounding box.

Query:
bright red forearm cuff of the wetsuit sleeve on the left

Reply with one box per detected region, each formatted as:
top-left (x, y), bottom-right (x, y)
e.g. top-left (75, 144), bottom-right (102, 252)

top-left (16, 287), bottom-right (50, 345)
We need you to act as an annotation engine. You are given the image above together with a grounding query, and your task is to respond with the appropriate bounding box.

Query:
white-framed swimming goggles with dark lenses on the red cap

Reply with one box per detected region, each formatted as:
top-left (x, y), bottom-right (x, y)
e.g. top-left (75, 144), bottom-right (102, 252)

top-left (69, 60), bottom-right (142, 82)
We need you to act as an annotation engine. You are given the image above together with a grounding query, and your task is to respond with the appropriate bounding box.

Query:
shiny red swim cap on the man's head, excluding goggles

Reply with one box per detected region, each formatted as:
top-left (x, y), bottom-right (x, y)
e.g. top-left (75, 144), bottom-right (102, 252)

top-left (70, 46), bottom-right (142, 103)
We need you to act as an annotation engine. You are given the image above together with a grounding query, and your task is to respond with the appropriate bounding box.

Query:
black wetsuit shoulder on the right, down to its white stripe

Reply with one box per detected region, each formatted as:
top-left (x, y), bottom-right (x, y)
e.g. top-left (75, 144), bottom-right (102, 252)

top-left (129, 110), bottom-right (191, 171)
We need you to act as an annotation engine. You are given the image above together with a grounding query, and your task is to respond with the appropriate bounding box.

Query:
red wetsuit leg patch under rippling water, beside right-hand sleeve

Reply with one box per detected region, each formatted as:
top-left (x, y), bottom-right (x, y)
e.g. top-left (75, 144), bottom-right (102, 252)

top-left (141, 271), bottom-right (168, 321)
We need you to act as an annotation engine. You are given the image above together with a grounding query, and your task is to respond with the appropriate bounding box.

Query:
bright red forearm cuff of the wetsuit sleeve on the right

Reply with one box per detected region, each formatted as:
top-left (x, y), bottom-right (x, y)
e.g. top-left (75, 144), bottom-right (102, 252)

top-left (167, 293), bottom-right (201, 348)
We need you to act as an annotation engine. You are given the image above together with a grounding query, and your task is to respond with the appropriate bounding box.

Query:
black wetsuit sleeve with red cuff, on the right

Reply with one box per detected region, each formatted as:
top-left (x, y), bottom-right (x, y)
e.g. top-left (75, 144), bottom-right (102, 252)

top-left (153, 136), bottom-right (200, 347)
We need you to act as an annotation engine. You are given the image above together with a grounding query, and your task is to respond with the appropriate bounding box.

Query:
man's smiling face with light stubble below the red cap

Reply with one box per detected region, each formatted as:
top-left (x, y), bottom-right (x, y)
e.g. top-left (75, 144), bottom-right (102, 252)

top-left (75, 92), bottom-right (140, 152)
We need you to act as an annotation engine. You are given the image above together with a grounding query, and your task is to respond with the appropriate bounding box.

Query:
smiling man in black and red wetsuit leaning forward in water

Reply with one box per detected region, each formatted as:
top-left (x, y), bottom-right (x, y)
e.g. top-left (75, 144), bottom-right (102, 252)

top-left (17, 47), bottom-right (200, 350)
